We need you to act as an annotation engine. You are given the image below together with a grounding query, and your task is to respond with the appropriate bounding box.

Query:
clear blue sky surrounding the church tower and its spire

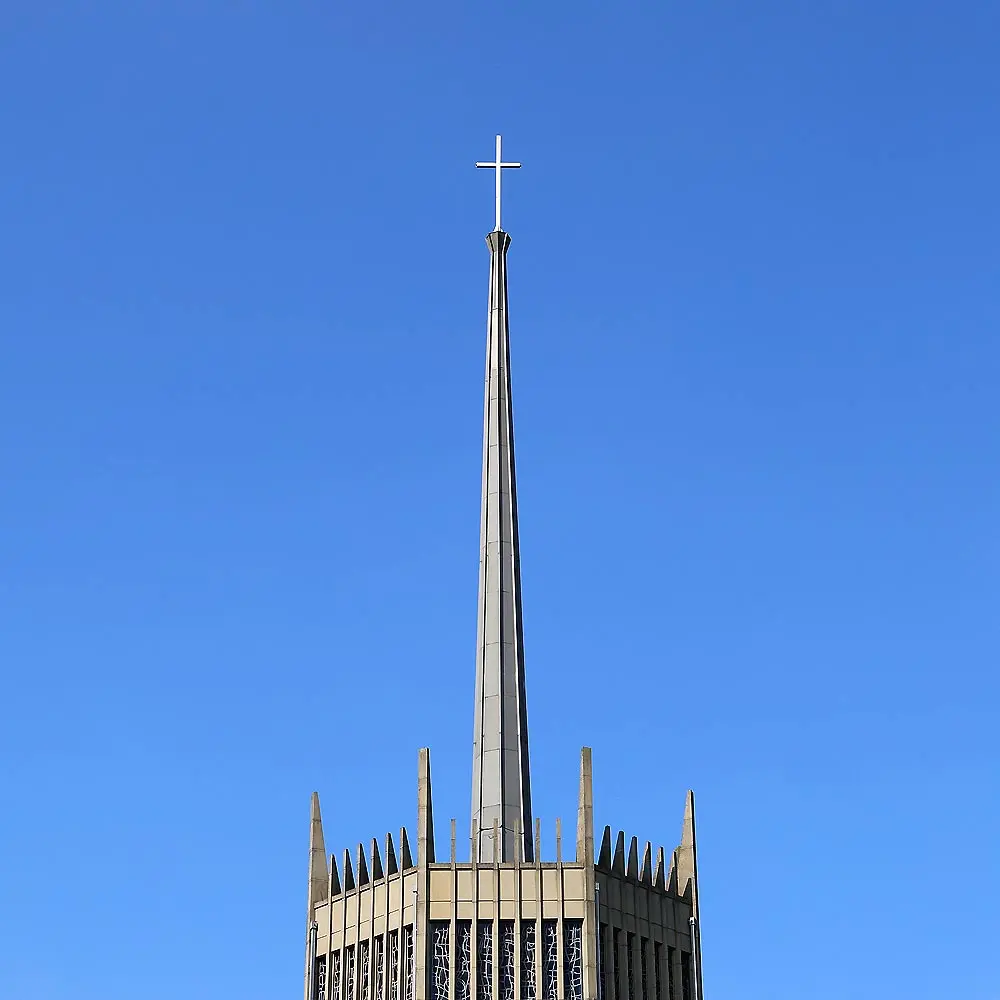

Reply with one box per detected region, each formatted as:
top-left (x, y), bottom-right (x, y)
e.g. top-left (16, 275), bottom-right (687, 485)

top-left (0, 0), bottom-right (1000, 1000)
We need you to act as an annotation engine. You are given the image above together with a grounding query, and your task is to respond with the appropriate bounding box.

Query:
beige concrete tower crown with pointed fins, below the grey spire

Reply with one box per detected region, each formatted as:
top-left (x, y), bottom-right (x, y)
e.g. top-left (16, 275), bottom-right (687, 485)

top-left (304, 748), bottom-right (701, 1000)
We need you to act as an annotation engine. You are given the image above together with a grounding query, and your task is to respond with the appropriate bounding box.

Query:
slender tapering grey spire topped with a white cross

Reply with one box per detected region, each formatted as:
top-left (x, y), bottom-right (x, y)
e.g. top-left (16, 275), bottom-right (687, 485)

top-left (472, 136), bottom-right (534, 862)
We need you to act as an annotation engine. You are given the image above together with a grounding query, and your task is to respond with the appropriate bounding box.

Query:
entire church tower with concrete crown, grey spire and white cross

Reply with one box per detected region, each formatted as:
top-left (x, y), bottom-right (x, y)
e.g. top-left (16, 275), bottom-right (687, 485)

top-left (304, 136), bottom-right (702, 1000)
